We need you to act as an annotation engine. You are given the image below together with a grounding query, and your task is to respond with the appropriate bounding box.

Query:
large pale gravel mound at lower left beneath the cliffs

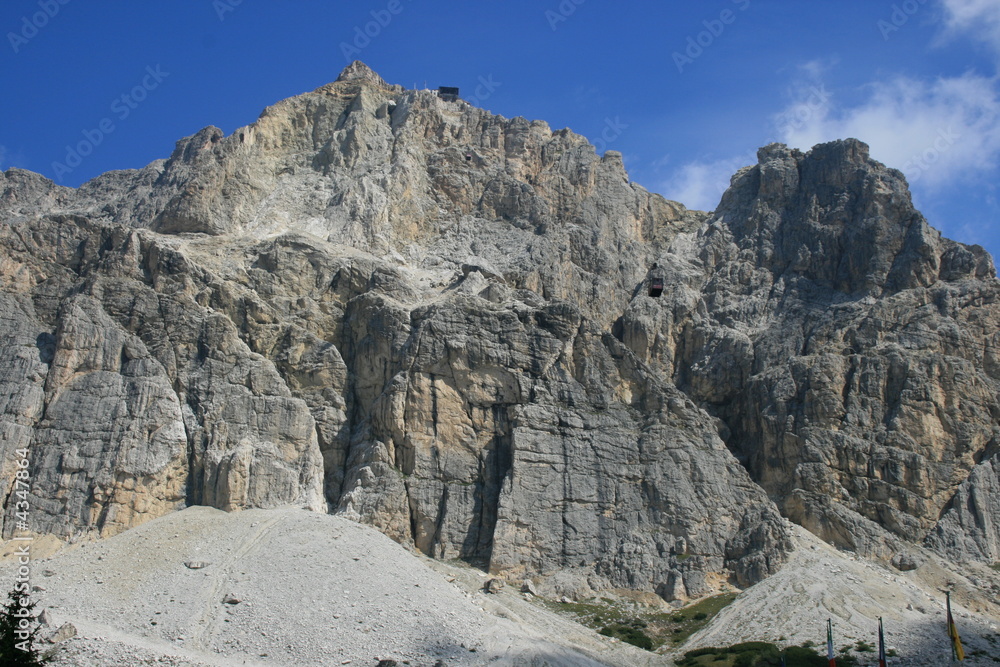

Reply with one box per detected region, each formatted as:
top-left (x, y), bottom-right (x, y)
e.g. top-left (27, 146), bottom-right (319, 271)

top-left (6, 507), bottom-right (642, 667)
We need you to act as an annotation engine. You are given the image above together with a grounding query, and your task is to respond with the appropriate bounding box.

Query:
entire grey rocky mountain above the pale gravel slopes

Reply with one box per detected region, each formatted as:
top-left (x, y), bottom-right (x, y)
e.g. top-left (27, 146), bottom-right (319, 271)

top-left (0, 63), bottom-right (1000, 640)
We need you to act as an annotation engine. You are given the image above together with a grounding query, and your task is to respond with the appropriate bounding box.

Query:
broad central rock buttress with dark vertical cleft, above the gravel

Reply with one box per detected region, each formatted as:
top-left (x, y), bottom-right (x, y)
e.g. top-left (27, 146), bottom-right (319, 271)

top-left (340, 297), bottom-right (784, 595)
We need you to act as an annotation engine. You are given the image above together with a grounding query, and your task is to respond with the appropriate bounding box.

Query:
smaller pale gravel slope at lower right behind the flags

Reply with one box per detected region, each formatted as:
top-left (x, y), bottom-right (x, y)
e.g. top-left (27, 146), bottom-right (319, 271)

top-left (684, 526), bottom-right (1000, 667)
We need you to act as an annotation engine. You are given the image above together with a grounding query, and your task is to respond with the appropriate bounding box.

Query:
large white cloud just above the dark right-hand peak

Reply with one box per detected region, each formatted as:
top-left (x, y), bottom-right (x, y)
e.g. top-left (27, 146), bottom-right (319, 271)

top-left (774, 73), bottom-right (1000, 188)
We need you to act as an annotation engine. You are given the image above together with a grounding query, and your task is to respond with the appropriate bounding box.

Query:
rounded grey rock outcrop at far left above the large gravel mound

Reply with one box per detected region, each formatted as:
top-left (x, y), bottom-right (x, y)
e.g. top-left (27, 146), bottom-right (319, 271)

top-left (0, 218), bottom-right (326, 537)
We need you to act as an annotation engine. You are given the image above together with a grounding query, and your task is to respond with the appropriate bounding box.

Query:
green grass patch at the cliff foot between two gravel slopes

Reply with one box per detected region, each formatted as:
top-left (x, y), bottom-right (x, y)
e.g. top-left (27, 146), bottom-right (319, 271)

top-left (539, 593), bottom-right (737, 648)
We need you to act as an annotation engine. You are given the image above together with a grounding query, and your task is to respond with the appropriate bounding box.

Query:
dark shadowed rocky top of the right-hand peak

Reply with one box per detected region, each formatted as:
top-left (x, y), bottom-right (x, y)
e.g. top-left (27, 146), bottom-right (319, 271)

top-left (716, 139), bottom-right (995, 294)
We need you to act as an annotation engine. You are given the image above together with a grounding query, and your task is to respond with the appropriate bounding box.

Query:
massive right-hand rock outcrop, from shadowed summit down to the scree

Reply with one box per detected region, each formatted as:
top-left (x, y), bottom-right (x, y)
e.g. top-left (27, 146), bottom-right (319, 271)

top-left (623, 140), bottom-right (1000, 558)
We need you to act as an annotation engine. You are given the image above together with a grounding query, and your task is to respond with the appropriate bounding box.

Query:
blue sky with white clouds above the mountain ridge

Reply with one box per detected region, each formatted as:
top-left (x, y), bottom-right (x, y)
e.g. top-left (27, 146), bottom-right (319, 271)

top-left (0, 0), bottom-right (1000, 264)
